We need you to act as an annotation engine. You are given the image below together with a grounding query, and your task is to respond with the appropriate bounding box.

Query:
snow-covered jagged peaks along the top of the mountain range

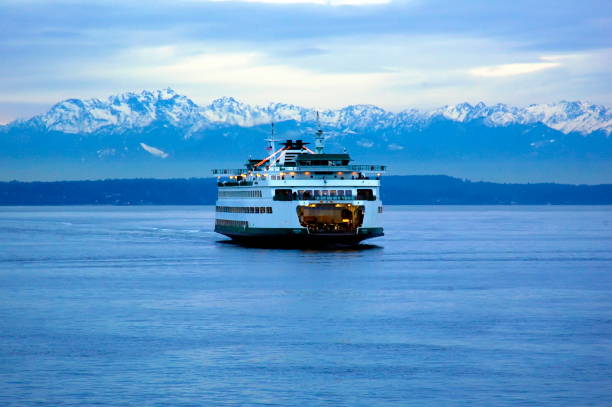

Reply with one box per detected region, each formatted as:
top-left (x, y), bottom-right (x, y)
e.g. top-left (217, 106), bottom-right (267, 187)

top-left (5, 89), bottom-right (612, 137)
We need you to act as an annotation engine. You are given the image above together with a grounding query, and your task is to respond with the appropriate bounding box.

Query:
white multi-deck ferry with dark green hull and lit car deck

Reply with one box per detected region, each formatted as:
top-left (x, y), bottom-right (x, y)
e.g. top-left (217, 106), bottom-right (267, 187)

top-left (213, 127), bottom-right (386, 245)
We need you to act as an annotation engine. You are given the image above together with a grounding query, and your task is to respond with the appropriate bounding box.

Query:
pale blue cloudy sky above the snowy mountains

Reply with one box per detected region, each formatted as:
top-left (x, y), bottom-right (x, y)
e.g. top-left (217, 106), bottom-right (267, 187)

top-left (0, 0), bottom-right (612, 123)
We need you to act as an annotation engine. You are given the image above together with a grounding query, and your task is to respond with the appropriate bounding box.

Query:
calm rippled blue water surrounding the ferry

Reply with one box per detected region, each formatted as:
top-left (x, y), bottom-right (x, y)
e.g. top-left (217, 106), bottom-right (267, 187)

top-left (0, 207), bottom-right (612, 407)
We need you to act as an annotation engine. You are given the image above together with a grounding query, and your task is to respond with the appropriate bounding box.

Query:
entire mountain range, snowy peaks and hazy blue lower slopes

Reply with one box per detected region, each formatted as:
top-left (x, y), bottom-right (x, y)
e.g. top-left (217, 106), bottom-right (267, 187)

top-left (0, 89), bottom-right (612, 183)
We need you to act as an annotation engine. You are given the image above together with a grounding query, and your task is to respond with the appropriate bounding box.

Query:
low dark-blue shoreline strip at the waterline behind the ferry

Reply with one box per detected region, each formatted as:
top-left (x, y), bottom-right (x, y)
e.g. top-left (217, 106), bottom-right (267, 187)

top-left (0, 175), bottom-right (612, 205)
